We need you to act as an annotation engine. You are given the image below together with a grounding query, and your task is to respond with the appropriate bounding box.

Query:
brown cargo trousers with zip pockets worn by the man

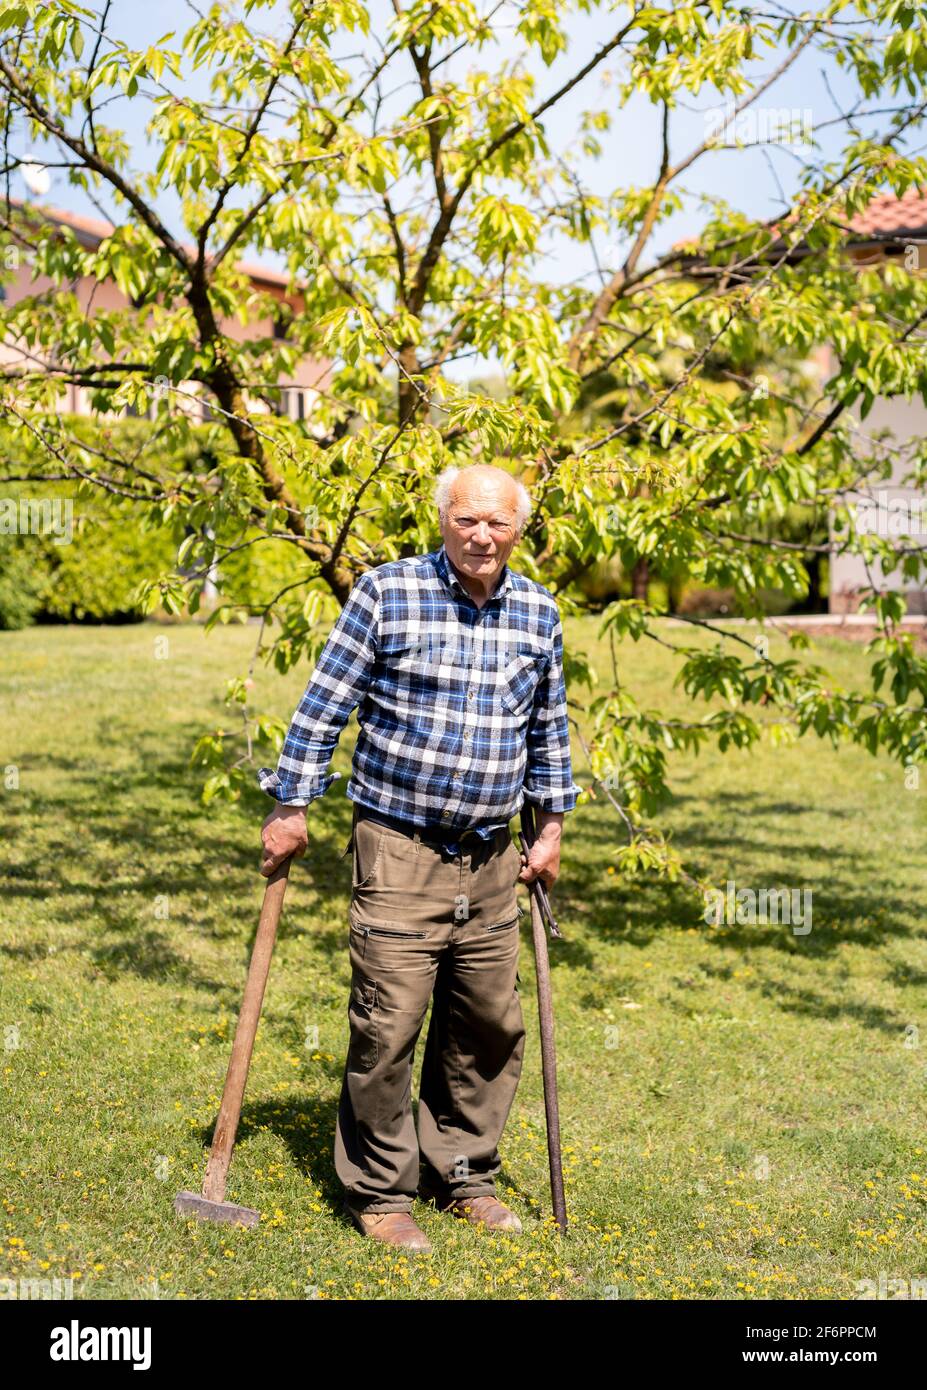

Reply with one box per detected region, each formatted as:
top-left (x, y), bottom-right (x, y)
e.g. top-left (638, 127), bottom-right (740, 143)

top-left (335, 816), bottom-right (525, 1212)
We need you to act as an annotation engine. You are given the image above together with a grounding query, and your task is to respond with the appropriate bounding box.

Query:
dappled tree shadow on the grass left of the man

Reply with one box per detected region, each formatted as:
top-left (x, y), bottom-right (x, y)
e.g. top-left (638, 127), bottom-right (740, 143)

top-left (0, 724), bottom-right (352, 988)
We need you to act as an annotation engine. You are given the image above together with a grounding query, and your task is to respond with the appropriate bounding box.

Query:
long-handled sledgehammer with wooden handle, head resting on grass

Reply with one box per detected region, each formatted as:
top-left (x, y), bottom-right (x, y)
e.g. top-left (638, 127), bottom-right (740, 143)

top-left (174, 858), bottom-right (293, 1226)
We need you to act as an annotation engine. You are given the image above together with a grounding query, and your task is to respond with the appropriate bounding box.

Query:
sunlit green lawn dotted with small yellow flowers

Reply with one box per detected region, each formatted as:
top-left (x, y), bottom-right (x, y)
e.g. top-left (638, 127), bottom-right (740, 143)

top-left (0, 620), bottom-right (927, 1300)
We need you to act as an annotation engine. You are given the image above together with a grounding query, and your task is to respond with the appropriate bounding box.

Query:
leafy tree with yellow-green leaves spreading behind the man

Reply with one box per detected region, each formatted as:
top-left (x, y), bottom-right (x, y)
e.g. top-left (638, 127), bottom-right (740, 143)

top-left (0, 0), bottom-right (927, 876)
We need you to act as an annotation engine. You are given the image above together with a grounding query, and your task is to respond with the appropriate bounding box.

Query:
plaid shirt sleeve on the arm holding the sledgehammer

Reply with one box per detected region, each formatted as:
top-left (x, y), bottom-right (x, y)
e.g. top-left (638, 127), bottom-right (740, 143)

top-left (257, 574), bottom-right (379, 806)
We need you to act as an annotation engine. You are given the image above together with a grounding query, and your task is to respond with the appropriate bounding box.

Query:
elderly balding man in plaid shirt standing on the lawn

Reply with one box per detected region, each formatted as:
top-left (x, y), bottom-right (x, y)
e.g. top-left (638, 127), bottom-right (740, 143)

top-left (260, 464), bottom-right (580, 1250)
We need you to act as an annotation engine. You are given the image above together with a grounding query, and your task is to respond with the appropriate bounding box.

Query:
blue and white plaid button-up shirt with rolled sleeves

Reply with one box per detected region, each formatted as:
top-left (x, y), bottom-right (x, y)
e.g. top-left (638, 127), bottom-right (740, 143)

top-left (259, 545), bottom-right (581, 838)
